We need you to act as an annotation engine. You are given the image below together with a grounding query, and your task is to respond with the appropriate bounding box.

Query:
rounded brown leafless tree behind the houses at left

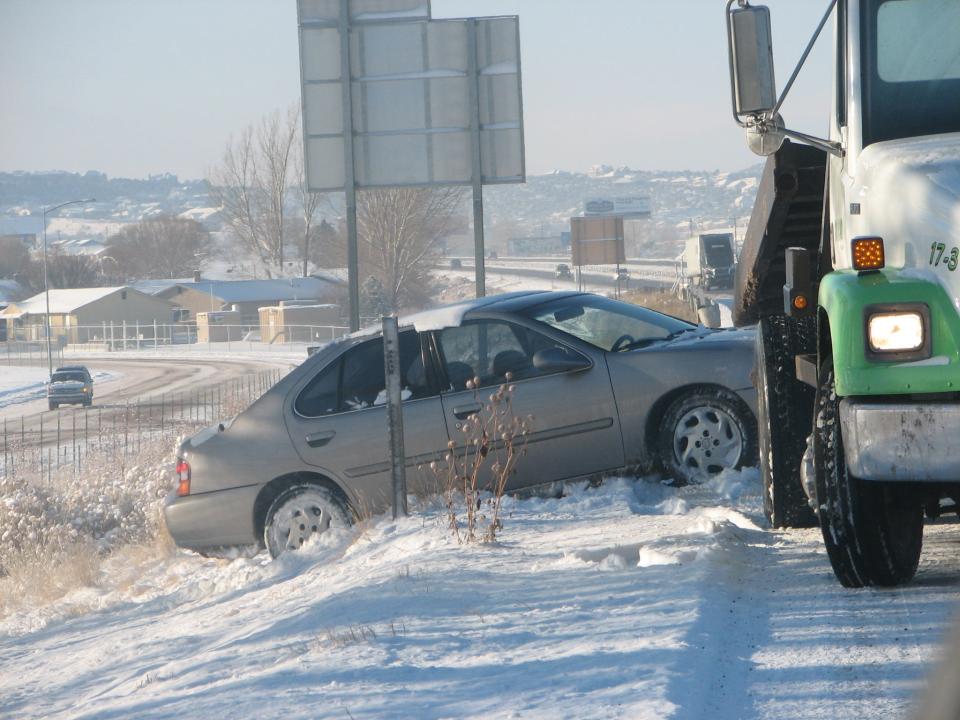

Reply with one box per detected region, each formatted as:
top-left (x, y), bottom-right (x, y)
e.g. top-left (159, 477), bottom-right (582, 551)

top-left (106, 215), bottom-right (212, 279)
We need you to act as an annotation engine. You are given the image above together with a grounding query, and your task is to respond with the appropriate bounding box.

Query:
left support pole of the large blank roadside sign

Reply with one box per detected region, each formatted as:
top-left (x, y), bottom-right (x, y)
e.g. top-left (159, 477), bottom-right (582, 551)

top-left (340, 0), bottom-right (360, 332)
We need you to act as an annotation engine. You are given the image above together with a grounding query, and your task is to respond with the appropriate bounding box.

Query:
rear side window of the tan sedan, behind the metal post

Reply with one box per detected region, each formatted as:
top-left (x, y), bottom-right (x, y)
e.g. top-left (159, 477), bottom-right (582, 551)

top-left (295, 331), bottom-right (432, 417)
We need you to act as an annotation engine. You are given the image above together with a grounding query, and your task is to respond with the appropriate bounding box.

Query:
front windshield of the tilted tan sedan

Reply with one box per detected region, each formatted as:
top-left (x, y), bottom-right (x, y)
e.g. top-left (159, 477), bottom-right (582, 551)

top-left (523, 295), bottom-right (697, 351)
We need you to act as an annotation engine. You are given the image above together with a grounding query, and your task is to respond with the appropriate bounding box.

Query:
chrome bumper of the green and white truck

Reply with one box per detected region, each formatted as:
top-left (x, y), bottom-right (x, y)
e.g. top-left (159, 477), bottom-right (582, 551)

top-left (840, 398), bottom-right (960, 482)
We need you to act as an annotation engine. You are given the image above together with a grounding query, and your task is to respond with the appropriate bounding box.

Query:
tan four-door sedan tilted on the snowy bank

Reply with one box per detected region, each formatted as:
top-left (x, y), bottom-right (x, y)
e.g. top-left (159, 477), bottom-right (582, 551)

top-left (164, 292), bottom-right (757, 556)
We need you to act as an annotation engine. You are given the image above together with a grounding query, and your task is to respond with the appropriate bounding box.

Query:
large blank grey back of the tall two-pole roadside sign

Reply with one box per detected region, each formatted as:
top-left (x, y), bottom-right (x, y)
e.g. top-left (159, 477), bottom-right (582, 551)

top-left (300, 0), bottom-right (526, 192)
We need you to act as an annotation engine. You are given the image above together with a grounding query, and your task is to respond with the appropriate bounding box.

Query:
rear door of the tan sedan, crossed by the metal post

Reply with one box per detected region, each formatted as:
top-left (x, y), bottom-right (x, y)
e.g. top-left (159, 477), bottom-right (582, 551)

top-left (288, 331), bottom-right (448, 508)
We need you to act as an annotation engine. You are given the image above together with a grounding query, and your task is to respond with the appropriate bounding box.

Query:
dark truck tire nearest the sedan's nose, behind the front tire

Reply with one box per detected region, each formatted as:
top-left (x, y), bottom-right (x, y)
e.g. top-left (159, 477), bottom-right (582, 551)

top-left (755, 315), bottom-right (817, 528)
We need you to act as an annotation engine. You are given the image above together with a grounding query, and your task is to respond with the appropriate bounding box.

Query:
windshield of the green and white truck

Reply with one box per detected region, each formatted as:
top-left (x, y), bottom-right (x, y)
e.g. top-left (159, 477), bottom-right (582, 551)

top-left (861, 0), bottom-right (960, 146)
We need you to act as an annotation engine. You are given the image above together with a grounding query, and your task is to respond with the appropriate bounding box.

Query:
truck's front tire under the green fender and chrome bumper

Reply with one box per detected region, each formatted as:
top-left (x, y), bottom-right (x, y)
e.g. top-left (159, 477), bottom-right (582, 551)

top-left (813, 361), bottom-right (923, 588)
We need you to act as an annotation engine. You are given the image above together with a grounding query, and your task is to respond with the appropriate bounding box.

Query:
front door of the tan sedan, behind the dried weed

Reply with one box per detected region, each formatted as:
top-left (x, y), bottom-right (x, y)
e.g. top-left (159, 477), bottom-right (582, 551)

top-left (436, 320), bottom-right (624, 490)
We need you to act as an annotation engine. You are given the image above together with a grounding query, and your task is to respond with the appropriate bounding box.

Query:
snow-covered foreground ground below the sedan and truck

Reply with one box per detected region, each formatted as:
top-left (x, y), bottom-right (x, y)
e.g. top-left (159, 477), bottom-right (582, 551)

top-left (0, 470), bottom-right (960, 720)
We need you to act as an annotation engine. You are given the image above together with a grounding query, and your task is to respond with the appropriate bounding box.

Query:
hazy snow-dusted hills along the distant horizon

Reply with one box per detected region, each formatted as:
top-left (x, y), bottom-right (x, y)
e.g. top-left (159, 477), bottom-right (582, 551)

top-left (0, 165), bottom-right (762, 255)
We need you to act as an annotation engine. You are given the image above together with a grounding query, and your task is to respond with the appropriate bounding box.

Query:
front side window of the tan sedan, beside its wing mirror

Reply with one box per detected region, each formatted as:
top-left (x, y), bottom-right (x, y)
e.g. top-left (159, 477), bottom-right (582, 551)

top-left (439, 321), bottom-right (576, 391)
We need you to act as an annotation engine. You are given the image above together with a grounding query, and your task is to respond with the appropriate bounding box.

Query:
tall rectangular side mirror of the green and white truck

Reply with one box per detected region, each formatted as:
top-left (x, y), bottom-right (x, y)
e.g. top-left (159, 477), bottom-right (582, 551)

top-left (727, 0), bottom-right (777, 120)
